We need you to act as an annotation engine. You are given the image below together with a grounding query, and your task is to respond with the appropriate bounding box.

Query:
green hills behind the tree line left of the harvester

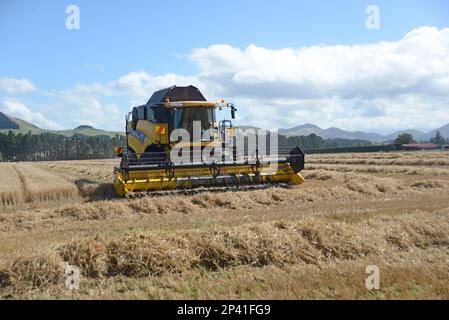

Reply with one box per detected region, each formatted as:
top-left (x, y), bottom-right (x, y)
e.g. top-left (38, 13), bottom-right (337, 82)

top-left (0, 112), bottom-right (124, 137)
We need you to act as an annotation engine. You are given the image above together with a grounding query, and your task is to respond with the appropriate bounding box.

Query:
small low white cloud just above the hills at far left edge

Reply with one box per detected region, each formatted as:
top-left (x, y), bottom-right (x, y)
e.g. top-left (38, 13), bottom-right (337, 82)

top-left (1, 98), bottom-right (62, 130)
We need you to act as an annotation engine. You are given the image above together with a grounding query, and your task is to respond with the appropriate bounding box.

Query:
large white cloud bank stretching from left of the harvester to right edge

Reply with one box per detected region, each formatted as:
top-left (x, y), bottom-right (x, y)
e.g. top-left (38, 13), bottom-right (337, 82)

top-left (17, 27), bottom-right (449, 133)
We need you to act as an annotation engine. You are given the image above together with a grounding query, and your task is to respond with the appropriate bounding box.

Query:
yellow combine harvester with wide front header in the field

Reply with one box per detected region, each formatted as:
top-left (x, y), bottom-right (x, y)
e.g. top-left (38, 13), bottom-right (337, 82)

top-left (114, 86), bottom-right (304, 196)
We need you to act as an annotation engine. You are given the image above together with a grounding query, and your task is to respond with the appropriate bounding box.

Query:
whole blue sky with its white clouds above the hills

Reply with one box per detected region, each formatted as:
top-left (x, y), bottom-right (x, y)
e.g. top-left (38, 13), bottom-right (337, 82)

top-left (0, 0), bottom-right (449, 132)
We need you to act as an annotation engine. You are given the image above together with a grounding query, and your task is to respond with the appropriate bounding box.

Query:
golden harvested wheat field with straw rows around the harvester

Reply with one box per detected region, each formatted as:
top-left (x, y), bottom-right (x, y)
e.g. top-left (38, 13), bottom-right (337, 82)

top-left (0, 152), bottom-right (449, 299)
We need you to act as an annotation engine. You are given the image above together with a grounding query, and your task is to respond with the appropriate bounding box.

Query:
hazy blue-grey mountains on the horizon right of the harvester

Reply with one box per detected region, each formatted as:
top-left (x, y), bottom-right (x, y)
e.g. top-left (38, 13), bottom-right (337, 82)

top-left (279, 123), bottom-right (449, 142)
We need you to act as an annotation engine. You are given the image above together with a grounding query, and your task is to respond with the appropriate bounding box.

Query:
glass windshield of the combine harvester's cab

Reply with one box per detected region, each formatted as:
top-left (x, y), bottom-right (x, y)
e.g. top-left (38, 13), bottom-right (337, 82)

top-left (170, 107), bottom-right (215, 140)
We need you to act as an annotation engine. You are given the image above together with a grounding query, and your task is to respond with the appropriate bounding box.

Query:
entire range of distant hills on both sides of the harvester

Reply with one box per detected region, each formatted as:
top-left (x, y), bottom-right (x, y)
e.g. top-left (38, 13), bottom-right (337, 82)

top-left (0, 112), bottom-right (449, 142)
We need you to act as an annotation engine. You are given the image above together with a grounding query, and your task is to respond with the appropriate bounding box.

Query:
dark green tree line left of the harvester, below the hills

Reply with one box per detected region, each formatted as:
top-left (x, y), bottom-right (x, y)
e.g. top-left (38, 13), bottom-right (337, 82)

top-left (0, 131), bottom-right (126, 161)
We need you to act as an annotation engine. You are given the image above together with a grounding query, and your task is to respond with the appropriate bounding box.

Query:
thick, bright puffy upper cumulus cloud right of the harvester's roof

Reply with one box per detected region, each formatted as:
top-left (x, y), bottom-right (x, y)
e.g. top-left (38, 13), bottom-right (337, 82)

top-left (190, 27), bottom-right (449, 99)
